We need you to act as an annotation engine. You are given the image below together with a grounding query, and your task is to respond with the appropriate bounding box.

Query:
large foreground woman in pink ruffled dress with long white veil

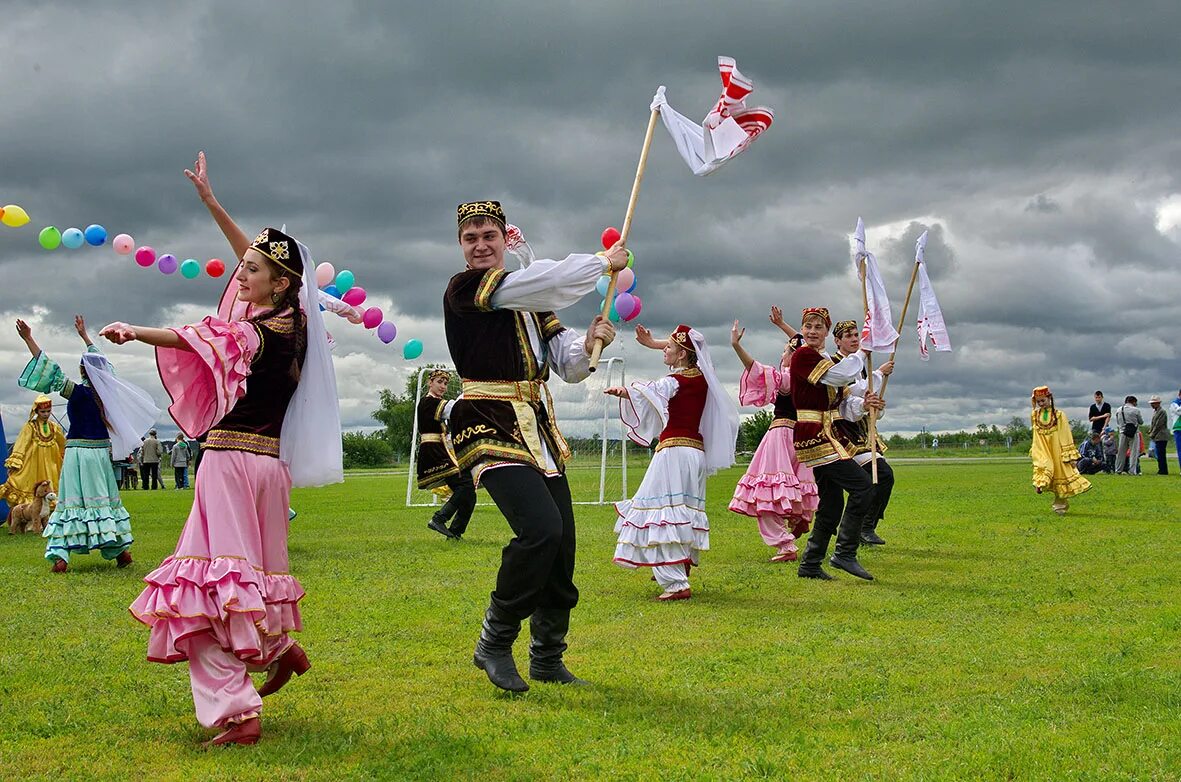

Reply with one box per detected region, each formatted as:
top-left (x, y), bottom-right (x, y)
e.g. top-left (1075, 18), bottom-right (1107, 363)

top-left (102, 154), bottom-right (342, 745)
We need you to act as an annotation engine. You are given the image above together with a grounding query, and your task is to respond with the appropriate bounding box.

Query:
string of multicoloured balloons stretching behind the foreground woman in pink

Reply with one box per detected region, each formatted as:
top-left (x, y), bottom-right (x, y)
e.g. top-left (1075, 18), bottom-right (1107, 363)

top-left (0, 203), bottom-right (423, 352)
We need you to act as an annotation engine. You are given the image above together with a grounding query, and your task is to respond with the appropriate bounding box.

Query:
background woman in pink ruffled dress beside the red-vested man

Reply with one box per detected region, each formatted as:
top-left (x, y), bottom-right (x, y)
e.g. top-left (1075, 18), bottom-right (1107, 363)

top-left (730, 307), bottom-right (818, 562)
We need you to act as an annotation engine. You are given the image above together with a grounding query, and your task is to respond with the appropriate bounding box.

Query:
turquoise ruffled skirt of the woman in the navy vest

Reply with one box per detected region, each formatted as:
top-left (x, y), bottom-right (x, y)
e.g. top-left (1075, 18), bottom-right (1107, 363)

top-left (43, 441), bottom-right (133, 562)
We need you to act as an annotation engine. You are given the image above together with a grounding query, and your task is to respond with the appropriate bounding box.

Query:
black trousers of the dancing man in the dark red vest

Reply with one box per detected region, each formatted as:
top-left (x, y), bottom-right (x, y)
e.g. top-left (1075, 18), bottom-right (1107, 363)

top-left (805, 458), bottom-right (874, 565)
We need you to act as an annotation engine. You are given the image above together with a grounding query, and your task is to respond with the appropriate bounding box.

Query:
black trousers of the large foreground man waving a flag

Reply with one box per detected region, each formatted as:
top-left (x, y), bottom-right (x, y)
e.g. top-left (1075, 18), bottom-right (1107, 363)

top-left (481, 465), bottom-right (579, 620)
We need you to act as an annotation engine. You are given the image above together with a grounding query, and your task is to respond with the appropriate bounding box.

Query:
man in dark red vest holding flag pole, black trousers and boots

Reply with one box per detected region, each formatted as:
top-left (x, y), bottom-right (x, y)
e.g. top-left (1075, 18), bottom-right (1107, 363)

top-left (789, 307), bottom-right (882, 581)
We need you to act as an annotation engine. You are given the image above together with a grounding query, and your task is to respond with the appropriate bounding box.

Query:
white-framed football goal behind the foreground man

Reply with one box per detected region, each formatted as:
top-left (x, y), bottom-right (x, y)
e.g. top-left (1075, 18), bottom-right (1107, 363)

top-left (406, 357), bottom-right (648, 507)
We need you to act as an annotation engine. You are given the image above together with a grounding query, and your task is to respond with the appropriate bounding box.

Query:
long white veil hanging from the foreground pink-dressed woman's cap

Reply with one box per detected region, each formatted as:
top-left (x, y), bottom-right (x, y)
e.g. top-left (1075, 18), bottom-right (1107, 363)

top-left (279, 241), bottom-right (345, 487)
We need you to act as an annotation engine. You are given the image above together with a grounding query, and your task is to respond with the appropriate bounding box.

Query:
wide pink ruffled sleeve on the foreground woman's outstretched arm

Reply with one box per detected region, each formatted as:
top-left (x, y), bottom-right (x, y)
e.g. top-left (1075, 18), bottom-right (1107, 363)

top-left (156, 317), bottom-right (259, 437)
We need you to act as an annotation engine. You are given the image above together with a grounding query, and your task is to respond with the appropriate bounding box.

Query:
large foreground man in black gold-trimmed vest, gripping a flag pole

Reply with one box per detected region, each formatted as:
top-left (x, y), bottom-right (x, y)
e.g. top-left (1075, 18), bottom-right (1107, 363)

top-left (443, 201), bottom-right (627, 692)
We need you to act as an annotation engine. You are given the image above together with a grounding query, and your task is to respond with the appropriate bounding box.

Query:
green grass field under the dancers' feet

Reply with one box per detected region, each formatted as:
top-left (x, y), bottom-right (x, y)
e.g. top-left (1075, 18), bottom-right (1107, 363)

top-left (0, 463), bottom-right (1181, 781)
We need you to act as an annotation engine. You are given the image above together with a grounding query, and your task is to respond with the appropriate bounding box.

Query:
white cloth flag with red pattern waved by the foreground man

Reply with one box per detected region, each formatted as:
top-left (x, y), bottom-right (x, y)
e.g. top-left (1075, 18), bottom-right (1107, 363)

top-left (651, 57), bottom-right (775, 176)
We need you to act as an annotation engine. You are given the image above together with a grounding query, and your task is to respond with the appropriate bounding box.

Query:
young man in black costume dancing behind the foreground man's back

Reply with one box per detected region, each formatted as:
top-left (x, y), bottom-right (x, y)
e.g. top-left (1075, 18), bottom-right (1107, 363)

top-left (415, 370), bottom-right (476, 540)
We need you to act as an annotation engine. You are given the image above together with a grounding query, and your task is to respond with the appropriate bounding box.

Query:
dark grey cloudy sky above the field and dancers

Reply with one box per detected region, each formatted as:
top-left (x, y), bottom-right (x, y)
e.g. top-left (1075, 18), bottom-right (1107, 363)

top-left (0, 0), bottom-right (1181, 437)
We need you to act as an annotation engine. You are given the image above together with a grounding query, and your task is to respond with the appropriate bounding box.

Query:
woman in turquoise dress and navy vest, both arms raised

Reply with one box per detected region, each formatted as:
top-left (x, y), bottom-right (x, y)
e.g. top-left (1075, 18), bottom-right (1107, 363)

top-left (17, 315), bottom-right (159, 573)
